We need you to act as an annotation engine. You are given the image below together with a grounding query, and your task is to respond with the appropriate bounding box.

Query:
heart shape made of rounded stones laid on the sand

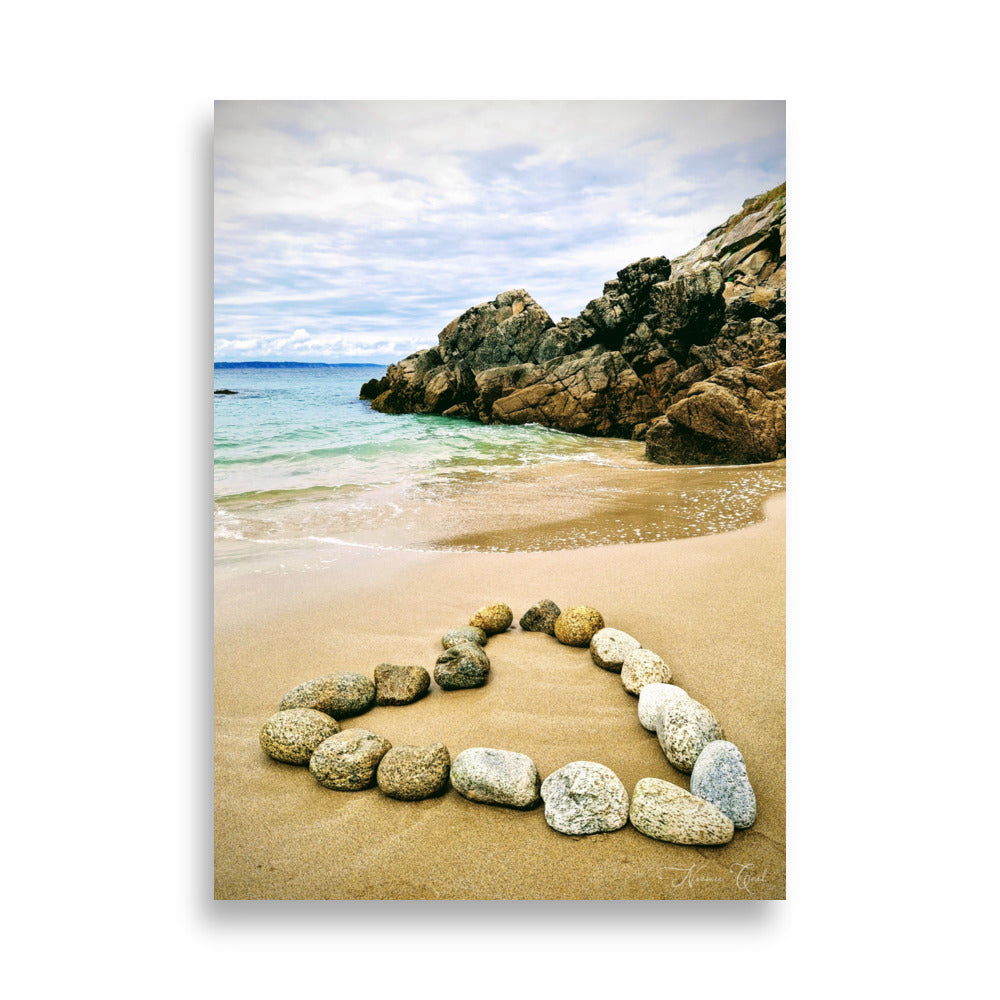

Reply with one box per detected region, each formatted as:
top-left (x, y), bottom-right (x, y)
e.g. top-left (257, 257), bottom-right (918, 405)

top-left (260, 600), bottom-right (757, 845)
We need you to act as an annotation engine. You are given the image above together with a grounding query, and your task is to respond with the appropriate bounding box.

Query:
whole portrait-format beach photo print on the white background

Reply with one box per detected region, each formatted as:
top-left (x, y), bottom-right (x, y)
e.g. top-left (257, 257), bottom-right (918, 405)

top-left (214, 101), bottom-right (786, 900)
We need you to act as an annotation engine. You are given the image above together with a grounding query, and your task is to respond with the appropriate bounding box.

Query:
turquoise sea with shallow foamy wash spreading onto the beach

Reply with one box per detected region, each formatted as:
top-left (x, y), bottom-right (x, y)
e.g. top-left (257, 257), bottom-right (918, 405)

top-left (214, 365), bottom-right (784, 560)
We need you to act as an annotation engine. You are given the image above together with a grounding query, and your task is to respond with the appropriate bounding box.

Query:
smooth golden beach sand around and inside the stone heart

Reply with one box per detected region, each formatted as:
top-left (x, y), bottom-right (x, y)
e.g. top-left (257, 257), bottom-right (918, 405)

top-left (215, 494), bottom-right (785, 899)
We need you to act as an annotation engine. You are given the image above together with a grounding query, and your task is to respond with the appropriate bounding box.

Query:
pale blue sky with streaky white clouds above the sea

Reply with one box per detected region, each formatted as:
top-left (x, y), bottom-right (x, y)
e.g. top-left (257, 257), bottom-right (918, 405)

top-left (215, 101), bottom-right (785, 363)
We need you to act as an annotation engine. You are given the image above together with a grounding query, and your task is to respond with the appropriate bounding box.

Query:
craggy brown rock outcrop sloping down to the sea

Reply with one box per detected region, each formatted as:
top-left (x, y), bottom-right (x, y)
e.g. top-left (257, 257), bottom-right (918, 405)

top-left (361, 184), bottom-right (785, 464)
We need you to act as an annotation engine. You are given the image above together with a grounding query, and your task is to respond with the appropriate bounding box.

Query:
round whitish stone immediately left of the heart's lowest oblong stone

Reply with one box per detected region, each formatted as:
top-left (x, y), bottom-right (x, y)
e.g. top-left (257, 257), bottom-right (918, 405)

top-left (541, 760), bottom-right (628, 835)
